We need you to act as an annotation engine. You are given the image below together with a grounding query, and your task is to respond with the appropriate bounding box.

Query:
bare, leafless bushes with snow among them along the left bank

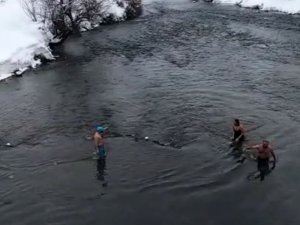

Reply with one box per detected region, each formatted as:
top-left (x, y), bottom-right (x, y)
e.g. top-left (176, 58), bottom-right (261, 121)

top-left (23, 0), bottom-right (141, 40)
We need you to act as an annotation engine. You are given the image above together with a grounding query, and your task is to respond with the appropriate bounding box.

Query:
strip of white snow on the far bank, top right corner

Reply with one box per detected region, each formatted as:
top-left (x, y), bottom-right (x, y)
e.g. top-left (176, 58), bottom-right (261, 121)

top-left (215, 0), bottom-right (300, 13)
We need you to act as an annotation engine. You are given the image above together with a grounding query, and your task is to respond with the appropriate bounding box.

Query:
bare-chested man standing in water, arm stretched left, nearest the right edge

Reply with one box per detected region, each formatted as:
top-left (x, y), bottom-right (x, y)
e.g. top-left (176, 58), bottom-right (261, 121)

top-left (247, 140), bottom-right (276, 181)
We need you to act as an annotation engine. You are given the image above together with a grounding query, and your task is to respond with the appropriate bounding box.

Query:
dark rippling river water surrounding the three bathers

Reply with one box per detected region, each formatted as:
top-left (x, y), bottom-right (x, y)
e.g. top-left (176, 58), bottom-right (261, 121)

top-left (0, 0), bottom-right (300, 225)
